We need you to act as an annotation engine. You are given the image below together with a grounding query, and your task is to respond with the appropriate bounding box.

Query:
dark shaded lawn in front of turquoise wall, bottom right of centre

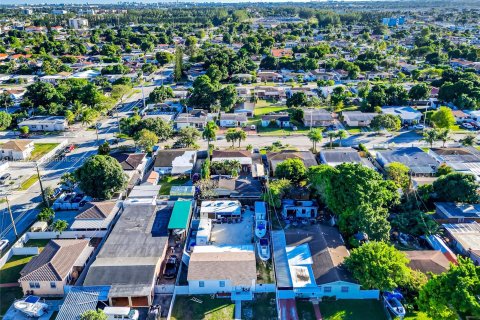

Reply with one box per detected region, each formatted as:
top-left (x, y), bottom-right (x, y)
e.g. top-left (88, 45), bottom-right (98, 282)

top-left (320, 300), bottom-right (386, 320)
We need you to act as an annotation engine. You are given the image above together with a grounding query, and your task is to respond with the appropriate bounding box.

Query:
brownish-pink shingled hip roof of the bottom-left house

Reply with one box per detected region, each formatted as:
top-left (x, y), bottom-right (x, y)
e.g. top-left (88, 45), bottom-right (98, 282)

top-left (18, 239), bottom-right (89, 281)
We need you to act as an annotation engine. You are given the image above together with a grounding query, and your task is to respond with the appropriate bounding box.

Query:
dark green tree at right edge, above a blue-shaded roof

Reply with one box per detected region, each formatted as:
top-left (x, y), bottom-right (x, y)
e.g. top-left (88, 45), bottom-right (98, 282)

top-left (433, 172), bottom-right (479, 203)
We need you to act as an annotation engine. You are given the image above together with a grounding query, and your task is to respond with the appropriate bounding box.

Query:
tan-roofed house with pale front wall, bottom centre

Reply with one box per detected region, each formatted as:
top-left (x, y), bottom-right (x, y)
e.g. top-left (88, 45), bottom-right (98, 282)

top-left (187, 245), bottom-right (257, 300)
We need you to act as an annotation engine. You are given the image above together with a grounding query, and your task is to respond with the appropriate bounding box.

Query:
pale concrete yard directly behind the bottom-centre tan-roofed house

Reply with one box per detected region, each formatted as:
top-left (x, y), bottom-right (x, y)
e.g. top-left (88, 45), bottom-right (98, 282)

top-left (210, 210), bottom-right (254, 245)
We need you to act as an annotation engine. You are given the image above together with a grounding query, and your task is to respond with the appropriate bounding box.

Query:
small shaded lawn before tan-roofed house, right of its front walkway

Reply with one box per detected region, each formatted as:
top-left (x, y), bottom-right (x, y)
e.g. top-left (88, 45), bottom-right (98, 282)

top-left (242, 293), bottom-right (278, 320)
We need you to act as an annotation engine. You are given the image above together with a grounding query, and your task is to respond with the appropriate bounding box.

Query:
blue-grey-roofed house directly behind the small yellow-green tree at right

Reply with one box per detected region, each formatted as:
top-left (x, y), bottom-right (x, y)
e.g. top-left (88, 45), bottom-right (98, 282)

top-left (377, 147), bottom-right (439, 176)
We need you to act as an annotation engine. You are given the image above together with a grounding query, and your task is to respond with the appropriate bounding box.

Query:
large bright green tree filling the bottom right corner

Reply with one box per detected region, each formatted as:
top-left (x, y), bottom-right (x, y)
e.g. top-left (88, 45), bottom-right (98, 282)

top-left (417, 257), bottom-right (480, 320)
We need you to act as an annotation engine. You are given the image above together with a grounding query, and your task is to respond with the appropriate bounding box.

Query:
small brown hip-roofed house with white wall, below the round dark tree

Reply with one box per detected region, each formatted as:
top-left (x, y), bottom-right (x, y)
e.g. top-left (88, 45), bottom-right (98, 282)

top-left (70, 201), bottom-right (122, 230)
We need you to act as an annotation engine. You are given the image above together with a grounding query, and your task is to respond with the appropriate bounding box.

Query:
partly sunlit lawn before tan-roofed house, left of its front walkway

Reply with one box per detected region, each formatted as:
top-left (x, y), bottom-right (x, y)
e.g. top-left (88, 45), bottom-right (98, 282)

top-left (171, 295), bottom-right (235, 320)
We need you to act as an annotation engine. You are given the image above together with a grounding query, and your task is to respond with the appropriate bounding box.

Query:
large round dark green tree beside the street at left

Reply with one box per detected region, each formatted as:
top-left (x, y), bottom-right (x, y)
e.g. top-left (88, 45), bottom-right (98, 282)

top-left (75, 155), bottom-right (126, 199)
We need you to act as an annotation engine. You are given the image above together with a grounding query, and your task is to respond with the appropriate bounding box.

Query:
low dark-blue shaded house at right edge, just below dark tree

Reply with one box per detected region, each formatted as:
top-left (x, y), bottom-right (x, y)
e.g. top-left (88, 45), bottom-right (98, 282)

top-left (434, 202), bottom-right (480, 223)
